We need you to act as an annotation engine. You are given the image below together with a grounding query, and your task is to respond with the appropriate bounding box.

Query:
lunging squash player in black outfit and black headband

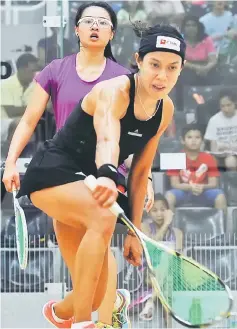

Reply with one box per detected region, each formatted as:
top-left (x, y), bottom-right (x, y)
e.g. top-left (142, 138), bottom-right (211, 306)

top-left (3, 26), bottom-right (186, 328)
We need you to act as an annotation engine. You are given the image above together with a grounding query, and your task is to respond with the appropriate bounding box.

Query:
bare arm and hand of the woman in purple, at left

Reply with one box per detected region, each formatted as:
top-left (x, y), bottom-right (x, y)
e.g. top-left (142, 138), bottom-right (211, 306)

top-left (3, 83), bottom-right (50, 192)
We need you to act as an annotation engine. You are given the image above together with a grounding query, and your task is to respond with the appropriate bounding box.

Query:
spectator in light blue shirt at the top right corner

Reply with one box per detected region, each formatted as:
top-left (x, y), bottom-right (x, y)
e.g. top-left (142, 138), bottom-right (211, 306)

top-left (200, 1), bottom-right (234, 56)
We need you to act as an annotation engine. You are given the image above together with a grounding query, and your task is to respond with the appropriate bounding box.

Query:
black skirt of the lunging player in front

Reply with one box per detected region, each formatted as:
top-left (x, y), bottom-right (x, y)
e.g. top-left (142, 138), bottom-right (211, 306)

top-left (17, 141), bottom-right (130, 224)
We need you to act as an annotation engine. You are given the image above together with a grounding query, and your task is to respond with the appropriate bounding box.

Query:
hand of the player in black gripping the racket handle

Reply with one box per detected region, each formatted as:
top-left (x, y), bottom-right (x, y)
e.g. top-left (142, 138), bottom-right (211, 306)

top-left (92, 177), bottom-right (118, 208)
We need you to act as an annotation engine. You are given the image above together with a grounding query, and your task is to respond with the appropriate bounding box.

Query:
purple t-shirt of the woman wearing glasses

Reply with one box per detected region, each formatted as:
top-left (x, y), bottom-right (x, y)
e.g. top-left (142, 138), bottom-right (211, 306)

top-left (35, 54), bottom-right (130, 130)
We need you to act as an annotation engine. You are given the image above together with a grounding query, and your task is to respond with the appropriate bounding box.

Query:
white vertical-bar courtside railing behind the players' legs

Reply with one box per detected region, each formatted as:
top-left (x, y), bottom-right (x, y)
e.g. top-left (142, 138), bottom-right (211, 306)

top-left (0, 234), bottom-right (237, 328)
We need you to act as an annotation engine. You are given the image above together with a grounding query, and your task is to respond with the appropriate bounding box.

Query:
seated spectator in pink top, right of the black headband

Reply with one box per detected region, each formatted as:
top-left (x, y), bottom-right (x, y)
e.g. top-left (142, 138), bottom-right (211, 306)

top-left (181, 16), bottom-right (218, 85)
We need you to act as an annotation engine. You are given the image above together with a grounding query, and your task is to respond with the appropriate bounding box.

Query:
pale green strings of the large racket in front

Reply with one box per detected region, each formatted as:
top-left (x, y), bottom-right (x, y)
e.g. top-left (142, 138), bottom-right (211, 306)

top-left (146, 241), bottom-right (229, 325)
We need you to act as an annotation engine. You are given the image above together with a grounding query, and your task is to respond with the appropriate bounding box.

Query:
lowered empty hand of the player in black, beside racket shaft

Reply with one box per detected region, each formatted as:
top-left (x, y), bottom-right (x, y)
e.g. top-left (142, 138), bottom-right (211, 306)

top-left (123, 235), bottom-right (142, 266)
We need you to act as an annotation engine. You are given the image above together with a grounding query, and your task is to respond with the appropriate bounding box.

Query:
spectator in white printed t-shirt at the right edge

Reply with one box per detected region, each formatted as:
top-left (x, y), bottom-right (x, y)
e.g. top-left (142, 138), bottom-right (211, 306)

top-left (205, 89), bottom-right (237, 171)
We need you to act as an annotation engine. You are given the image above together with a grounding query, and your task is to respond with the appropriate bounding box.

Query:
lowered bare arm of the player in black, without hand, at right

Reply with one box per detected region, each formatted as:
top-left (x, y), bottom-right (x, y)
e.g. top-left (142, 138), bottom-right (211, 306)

top-left (128, 97), bottom-right (174, 229)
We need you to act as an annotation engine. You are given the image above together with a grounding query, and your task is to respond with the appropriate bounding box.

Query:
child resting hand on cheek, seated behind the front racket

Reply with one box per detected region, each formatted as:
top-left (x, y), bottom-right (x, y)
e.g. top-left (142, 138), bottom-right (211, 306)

top-left (139, 193), bottom-right (183, 321)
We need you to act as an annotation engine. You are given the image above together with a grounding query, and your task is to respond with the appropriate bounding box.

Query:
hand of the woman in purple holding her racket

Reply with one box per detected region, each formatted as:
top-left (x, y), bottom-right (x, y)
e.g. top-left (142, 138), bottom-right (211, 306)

top-left (2, 162), bottom-right (20, 192)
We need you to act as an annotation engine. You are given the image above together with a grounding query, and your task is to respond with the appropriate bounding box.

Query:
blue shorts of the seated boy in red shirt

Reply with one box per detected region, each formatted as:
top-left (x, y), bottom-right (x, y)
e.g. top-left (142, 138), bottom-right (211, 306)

top-left (169, 189), bottom-right (223, 207)
